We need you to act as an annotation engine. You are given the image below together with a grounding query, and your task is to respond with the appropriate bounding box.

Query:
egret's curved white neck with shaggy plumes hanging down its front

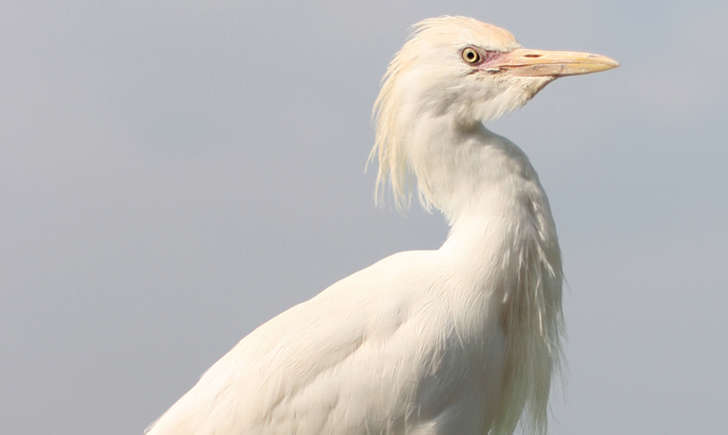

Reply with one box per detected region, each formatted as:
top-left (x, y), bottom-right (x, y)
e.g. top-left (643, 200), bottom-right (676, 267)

top-left (410, 115), bottom-right (562, 433)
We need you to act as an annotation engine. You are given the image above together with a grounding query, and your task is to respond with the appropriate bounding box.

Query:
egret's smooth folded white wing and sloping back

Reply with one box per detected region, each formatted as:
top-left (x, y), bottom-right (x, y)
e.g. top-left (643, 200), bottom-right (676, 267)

top-left (149, 251), bottom-right (480, 435)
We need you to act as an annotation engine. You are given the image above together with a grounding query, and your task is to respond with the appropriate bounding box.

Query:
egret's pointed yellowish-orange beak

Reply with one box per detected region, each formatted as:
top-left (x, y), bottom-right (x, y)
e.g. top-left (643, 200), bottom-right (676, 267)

top-left (485, 48), bottom-right (619, 77)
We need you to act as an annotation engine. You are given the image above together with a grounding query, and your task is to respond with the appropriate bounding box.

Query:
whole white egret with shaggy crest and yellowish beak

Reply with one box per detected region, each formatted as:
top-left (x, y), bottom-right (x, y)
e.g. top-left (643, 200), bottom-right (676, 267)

top-left (148, 16), bottom-right (618, 435)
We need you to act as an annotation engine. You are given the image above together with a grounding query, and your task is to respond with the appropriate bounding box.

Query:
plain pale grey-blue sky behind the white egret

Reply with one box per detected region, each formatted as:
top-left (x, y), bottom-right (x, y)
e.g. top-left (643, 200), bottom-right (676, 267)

top-left (0, 0), bottom-right (728, 435)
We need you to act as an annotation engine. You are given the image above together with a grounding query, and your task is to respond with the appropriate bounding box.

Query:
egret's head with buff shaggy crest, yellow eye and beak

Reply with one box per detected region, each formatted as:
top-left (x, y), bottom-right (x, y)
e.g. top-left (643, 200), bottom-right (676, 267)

top-left (370, 16), bottom-right (618, 209)
